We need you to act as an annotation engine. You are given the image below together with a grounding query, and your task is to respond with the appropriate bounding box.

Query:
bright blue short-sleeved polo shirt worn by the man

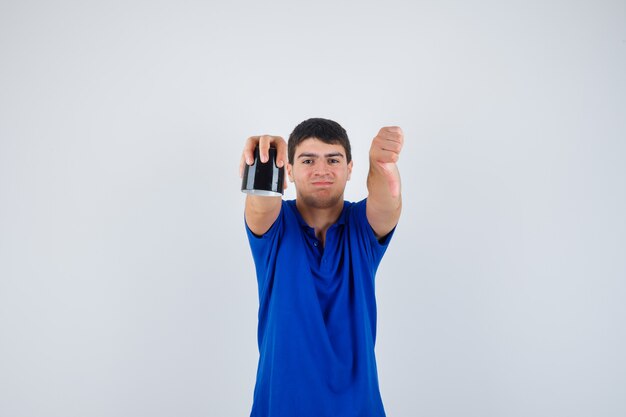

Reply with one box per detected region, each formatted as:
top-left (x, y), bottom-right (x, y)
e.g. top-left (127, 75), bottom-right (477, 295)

top-left (246, 200), bottom-right (393, 417)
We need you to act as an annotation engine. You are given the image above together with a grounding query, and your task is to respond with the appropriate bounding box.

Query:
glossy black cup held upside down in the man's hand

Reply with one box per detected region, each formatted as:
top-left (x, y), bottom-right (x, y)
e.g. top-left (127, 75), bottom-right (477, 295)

top-left (241, 146), bottom-right (285, 197)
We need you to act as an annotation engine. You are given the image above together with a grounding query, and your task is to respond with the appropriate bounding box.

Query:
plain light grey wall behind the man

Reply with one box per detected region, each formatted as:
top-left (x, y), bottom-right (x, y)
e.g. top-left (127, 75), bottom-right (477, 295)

top-left (0, 1), bottom-right (626, 417)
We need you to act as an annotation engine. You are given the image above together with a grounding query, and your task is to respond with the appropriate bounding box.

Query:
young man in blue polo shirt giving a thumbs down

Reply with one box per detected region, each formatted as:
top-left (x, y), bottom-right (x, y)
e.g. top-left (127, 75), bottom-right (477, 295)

top-left (240, 118), bottom-right (404, 417)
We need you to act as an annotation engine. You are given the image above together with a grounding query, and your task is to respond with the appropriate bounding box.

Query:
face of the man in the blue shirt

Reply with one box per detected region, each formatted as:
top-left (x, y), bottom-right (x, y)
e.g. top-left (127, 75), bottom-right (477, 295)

top-left (287, 138), bottom-right (352, 208)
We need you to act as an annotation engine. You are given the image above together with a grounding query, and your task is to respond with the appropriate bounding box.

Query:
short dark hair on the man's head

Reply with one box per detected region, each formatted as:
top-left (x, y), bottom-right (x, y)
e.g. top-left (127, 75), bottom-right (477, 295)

top-left (287, 117), bottom-right (352, 165)
